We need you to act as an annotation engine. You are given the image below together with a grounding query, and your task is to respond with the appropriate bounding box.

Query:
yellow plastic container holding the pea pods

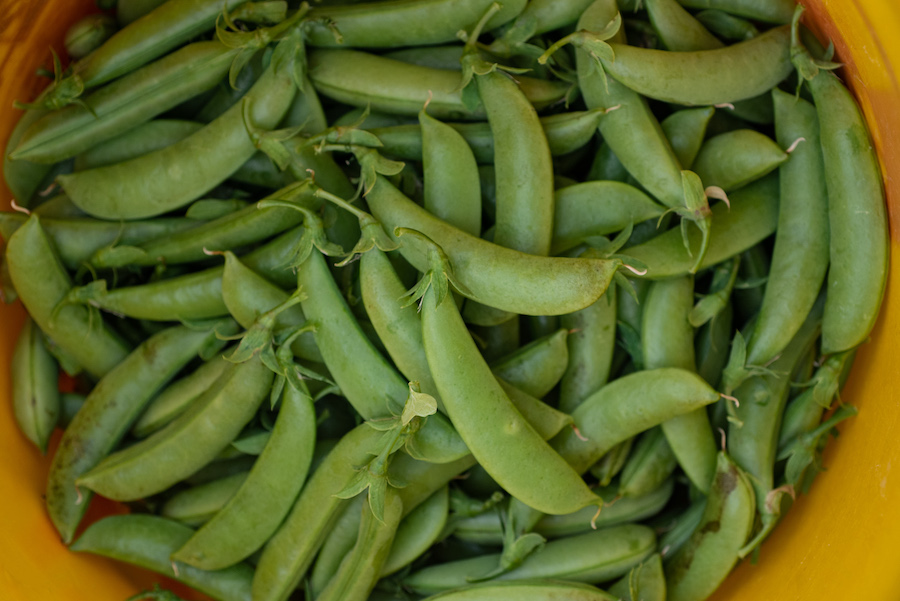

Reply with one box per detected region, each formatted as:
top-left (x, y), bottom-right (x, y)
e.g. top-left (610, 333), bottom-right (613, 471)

top-left (0, 0), bottom-right (900, 601)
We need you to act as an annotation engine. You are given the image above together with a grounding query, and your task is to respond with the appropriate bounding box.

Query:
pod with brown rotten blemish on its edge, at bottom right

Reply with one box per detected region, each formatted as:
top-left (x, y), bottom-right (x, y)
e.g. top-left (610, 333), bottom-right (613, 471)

top-left (665, 451), bottom-right (756, 601)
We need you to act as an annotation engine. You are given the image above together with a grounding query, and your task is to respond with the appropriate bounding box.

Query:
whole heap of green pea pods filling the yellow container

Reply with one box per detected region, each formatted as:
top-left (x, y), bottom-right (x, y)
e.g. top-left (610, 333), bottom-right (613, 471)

top-left (0, 0), bottom-right (888, 601)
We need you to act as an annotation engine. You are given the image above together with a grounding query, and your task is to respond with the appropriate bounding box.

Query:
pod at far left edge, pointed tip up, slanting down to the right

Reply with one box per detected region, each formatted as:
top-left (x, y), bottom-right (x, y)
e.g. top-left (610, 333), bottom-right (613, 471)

top-left (6, 215), bottom-right (129, 377)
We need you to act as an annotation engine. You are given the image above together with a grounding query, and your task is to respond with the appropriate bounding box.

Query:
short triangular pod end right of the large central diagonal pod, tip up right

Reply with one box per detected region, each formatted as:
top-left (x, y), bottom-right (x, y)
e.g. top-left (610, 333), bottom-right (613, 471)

top-left (491, 330), bottom-right (569, 399)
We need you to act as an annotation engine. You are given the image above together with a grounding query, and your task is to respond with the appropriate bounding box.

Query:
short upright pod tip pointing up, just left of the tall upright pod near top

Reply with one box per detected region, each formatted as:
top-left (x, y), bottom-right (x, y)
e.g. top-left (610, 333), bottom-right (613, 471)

top-left (419, 109), bottom-right (481, 236)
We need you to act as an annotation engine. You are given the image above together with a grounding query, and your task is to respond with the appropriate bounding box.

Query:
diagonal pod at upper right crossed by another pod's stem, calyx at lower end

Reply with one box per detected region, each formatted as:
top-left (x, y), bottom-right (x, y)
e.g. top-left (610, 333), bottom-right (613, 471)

top-left (575, 0), bottom-right (684, 207)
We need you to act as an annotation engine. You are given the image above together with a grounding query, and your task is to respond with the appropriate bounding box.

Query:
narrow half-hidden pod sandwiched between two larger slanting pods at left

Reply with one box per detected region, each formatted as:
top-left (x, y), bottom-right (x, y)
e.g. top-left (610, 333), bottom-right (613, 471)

top-left (131, 355), bottom-right (231, 438)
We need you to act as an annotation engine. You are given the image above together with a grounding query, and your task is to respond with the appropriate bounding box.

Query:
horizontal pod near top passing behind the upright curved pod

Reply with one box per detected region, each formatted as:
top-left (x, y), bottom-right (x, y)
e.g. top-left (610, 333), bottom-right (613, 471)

top-left (308, 49), bottom-right (569, 120)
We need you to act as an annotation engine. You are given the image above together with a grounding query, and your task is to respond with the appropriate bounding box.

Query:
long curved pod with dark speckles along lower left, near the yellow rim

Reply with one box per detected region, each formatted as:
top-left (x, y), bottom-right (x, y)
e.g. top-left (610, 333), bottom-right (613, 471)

top-left (47, 326), bottom-right (230, 543)
